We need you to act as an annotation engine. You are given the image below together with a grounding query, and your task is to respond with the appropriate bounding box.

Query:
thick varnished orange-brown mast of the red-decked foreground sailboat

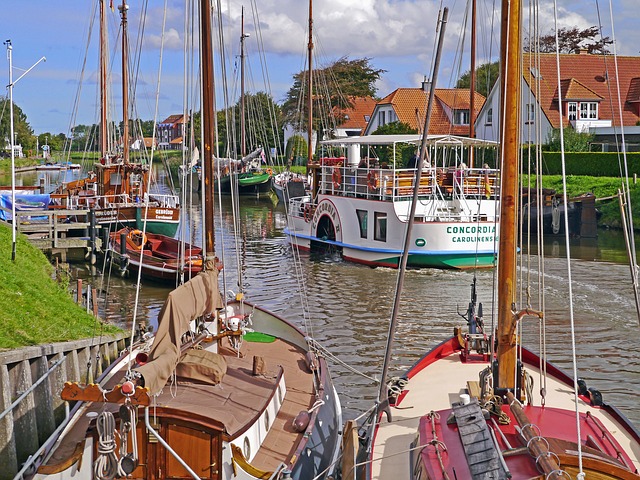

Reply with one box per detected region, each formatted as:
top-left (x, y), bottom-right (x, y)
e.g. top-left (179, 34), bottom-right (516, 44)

top-left (494, 0), bottom-right (522, 391)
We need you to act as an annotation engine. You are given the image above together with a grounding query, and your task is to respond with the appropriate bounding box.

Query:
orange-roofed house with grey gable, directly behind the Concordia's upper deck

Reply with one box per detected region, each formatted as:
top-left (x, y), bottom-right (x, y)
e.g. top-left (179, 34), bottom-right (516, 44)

top-left (364, 81), bottom-right (485, 136)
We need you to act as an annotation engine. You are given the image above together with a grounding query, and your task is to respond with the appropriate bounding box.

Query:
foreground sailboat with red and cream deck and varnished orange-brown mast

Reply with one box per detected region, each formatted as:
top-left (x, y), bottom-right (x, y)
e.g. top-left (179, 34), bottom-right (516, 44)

top-left (350, 0), bottom-right (640, 479)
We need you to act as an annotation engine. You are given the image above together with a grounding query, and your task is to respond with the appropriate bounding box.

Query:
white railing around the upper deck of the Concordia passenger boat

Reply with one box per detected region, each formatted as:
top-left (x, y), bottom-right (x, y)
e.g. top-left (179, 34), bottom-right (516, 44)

top-left (319, 165), bottom-right (498, 201)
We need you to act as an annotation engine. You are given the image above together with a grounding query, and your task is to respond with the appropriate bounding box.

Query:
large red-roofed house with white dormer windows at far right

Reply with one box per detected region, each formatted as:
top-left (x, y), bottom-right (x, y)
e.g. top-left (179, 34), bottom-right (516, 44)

top-left (476, 52), bottom-right (640, 147)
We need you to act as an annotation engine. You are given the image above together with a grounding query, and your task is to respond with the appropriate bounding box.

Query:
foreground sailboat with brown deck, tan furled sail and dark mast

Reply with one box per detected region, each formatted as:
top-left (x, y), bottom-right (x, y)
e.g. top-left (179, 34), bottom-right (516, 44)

top-left (28, 0), bottom-right (342, 480)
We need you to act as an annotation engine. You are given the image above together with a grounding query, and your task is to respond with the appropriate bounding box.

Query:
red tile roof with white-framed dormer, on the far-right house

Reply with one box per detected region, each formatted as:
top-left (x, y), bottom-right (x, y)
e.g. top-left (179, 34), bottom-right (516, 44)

top-left (522, 53), bottom-right (640, 128)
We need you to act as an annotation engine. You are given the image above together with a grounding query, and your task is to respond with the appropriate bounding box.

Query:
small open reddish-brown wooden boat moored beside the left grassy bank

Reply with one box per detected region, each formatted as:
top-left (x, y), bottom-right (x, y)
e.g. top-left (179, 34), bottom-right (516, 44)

top-left (111, 227), bottom-right (202, 282)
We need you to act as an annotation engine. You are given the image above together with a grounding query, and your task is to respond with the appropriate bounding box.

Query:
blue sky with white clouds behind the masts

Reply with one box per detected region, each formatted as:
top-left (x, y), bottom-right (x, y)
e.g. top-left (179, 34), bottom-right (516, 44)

top-left (0, 0), bottom-right (640, 134)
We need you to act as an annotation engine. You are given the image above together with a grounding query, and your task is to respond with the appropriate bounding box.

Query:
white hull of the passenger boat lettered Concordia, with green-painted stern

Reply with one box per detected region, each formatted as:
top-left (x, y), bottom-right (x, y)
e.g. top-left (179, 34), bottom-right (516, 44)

top-left (285, 195), bottom-right (498, 269)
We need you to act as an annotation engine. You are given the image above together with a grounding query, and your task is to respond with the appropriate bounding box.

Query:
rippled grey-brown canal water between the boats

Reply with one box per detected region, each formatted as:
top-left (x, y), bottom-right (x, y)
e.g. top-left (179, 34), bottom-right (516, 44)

top-left (6, 171), bottom-right (640, 425)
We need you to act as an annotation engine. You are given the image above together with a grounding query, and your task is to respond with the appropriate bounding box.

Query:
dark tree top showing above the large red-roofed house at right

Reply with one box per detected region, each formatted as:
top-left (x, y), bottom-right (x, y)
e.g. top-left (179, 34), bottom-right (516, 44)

top-left (524, 25), bottom-right (613, 54)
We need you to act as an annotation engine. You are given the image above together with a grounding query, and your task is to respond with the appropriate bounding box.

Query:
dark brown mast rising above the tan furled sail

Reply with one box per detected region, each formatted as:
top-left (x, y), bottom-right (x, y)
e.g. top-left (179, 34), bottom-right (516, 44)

top-left (200, 0), bottom-right (215, 257)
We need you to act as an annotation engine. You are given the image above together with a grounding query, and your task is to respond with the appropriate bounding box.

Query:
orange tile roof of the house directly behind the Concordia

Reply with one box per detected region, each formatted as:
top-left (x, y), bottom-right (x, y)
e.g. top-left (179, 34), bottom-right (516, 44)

top-left (378, 88), bottom-right (485, 136)
